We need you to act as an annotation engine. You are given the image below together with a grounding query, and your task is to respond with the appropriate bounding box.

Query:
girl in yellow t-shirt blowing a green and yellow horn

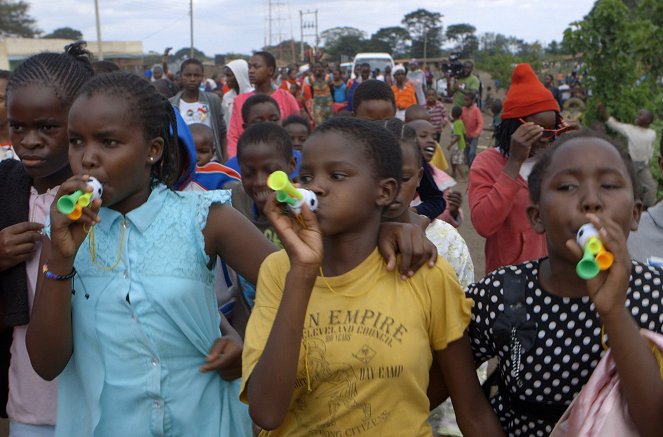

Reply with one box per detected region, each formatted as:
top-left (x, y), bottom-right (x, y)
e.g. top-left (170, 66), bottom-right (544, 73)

top-left (241, 118), bottom-right (502, 436)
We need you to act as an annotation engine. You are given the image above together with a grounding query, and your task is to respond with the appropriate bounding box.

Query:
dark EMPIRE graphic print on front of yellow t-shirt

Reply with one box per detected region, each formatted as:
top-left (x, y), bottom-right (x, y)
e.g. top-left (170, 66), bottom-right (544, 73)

top-left (292, 308), bottom-right (408, 436)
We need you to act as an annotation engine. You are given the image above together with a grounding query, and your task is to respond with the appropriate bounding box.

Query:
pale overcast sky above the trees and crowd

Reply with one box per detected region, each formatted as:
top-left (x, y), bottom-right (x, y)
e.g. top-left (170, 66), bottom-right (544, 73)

top-left (27, 0), bottom-right (594, 56)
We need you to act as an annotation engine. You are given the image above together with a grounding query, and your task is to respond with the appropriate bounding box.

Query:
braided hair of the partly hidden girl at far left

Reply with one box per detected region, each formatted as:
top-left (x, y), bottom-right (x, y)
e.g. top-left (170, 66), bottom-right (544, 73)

top-left (7, 41), bottom-right (94, 108)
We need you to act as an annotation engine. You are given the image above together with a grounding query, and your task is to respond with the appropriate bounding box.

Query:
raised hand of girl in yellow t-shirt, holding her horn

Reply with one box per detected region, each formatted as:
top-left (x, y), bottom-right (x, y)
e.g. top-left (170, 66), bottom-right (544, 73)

top-left (265, 193), bottom-right (323, 269)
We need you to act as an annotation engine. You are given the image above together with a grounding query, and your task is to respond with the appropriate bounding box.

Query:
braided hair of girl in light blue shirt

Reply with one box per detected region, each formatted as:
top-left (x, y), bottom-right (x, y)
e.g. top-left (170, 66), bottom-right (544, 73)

top-left (79, 71), bottom-right (183, 187)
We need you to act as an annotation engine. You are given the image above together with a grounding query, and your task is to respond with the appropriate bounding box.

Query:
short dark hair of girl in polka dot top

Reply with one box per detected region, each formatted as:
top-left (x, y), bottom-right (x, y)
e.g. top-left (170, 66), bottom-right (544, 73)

top-left (527, 128), bottom-right (640, 203)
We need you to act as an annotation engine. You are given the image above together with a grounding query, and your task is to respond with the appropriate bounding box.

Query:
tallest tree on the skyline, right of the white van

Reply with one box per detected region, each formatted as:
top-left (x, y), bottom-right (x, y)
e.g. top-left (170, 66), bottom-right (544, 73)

top-left (401, 9), bottom-right (444, 58)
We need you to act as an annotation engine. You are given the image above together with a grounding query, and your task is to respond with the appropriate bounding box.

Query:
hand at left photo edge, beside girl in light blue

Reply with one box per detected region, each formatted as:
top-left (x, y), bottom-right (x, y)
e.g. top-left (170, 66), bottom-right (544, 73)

top-left (0, 222), bottom-right (44, 272)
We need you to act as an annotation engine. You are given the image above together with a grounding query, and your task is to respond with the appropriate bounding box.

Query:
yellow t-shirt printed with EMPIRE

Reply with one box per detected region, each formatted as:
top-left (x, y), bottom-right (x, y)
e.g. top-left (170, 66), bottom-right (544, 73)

top-left (240, 249), bottom-right (472, 436)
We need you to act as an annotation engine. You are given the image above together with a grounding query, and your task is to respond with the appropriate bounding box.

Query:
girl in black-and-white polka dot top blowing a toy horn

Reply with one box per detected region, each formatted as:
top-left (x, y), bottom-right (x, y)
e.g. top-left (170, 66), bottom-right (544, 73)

top-left (467, 131), bottom-right (663, 436)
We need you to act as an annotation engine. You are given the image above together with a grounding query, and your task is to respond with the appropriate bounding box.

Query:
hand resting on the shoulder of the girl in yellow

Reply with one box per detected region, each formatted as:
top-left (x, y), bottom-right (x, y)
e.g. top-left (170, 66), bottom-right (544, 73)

top-left (378, 222), bottom-right (437, 279)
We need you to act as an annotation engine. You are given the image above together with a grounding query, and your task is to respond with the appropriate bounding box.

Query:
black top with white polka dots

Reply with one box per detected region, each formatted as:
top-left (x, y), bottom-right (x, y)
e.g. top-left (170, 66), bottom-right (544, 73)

top-left (467, 260), bottom-right (663, 436)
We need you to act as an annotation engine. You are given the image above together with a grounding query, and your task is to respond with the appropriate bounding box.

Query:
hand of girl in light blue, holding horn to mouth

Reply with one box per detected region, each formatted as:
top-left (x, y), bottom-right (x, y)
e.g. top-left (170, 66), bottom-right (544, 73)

top-left (51, 175), bottom-right (101, 258)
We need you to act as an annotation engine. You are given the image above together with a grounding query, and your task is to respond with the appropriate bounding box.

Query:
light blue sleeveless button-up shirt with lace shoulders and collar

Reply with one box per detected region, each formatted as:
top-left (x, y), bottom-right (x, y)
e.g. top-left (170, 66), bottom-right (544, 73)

top-left (48, 185), bottom-right (251, 437)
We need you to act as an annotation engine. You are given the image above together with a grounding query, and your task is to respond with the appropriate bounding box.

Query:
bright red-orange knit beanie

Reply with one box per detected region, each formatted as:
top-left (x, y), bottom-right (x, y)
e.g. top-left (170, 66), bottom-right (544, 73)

top-left (501, 64), bottom-right (559, 120)
